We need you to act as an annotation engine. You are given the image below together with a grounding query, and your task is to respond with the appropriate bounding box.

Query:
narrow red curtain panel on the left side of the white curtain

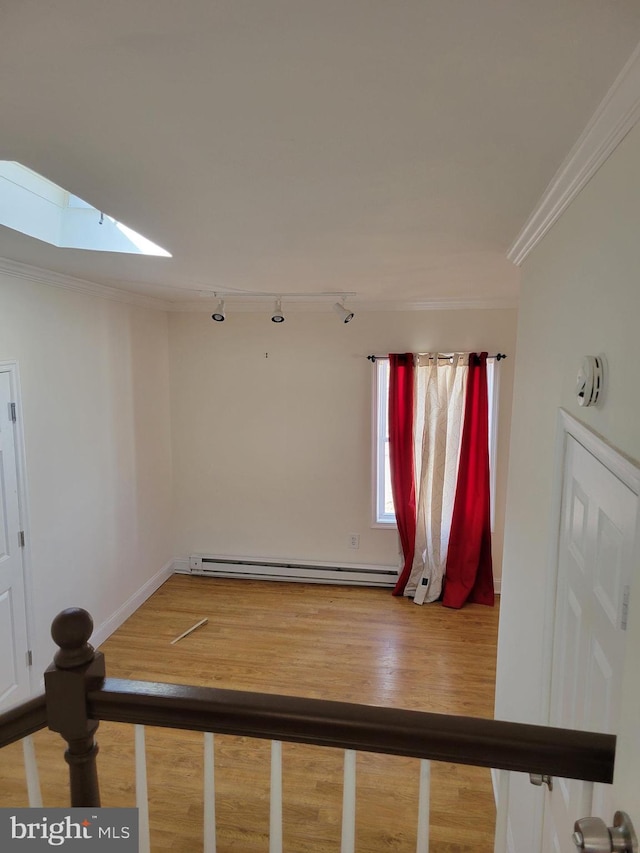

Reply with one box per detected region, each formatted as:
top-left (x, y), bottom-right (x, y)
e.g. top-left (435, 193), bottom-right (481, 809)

top-left (389, 352), bottom-right (416, 595)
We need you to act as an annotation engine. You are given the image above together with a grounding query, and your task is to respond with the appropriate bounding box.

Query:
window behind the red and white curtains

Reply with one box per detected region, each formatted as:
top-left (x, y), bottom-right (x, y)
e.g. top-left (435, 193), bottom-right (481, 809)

top-left (373, 358), bottom-right (499, 530)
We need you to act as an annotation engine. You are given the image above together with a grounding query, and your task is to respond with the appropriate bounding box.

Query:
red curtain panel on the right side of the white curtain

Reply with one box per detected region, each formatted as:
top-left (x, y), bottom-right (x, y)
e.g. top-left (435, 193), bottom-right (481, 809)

top-left (442, 352), bottom-right (494, 608)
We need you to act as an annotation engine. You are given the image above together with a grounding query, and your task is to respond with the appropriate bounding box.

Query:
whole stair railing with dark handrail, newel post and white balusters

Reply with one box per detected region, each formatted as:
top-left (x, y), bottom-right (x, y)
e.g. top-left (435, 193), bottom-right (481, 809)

top-left (0, 608), bottom-right (616, 853)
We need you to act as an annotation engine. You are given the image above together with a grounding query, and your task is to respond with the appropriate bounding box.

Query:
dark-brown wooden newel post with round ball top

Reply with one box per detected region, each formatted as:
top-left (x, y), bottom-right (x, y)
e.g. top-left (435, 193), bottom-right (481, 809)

top-left (44, 607), bottom-right (105, 807)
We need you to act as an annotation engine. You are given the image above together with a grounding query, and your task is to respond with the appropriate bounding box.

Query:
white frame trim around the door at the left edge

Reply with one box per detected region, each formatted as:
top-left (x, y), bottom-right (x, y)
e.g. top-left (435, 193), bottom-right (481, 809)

top-left (0, 359), bottom-right (36, 696)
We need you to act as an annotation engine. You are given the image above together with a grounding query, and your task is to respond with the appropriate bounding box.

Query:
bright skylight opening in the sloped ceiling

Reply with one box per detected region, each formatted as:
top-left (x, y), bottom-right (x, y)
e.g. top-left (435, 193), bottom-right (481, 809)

top-left (0, 160), bottom-right (171, 258)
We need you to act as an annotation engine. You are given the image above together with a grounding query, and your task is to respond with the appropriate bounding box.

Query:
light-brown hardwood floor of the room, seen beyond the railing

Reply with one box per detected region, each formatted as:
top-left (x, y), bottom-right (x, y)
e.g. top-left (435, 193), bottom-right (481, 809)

top-left (0, 575), bottom-right (498, 853)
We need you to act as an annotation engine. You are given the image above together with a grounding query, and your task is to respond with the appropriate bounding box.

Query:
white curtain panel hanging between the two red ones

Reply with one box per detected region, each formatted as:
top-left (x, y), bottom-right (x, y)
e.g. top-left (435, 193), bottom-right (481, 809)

top-left (404, 353), bottom-right (469, 604)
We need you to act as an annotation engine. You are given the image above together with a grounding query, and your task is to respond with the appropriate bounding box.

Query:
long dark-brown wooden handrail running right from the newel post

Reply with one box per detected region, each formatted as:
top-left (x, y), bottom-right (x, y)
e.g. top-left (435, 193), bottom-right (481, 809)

top-left (87, 678), bottom-right (616, 782)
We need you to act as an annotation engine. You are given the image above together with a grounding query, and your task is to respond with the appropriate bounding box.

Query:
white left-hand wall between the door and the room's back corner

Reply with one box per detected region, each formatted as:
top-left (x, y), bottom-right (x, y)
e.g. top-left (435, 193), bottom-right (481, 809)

top-left (0, 273), bottom-right (172, 672)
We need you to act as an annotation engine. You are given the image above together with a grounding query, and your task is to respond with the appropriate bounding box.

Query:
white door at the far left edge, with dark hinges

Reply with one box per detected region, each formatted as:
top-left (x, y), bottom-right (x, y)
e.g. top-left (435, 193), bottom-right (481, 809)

top-left (0, 372), bottom-right (30, 708)
